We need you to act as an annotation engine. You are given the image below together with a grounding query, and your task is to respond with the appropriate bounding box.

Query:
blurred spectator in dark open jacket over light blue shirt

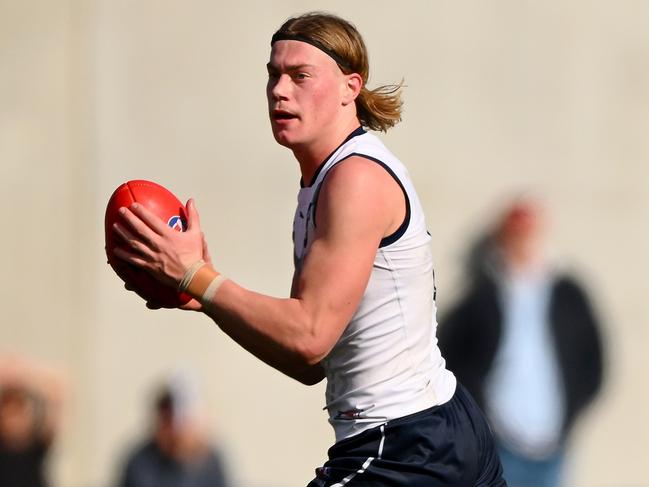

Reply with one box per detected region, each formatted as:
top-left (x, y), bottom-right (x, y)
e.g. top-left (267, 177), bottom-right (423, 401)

top-left (439, 198), bottom-right (603, 487)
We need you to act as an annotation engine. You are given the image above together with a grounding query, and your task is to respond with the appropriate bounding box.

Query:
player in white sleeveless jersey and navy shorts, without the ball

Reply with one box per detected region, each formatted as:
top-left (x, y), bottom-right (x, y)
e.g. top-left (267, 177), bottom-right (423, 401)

top-left (115, 13), bottom-right (504, 487)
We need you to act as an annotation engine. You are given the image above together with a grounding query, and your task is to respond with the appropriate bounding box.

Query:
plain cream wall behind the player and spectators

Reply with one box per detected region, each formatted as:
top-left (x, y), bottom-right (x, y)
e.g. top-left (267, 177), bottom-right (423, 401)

top-left (0, 0), bottom-right (649, 487)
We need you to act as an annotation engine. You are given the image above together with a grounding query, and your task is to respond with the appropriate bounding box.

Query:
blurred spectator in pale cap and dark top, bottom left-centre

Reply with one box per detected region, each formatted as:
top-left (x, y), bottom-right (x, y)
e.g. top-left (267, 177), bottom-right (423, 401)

top-left (119, 378), bottom-right (228, 487)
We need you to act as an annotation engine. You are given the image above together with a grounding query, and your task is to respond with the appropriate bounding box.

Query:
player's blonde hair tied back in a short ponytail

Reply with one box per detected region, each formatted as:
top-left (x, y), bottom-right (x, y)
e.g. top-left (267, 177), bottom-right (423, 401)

top-left (271, 12), bottom-right (403, 132)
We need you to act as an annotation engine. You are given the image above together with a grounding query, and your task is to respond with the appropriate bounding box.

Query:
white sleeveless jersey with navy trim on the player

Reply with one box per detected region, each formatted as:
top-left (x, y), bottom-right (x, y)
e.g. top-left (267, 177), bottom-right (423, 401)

top-left (293, 129), bottom-right (455, 441)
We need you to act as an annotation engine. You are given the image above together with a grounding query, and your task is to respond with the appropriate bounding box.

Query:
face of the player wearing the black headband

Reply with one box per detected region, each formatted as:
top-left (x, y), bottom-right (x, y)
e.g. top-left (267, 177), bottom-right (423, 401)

top-left (266, 41), bottom-right (345, 148)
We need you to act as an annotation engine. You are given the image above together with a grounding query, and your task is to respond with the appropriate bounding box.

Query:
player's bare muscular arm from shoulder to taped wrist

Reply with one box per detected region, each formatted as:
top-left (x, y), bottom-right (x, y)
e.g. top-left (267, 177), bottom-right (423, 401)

top-left (118, 158), bottom-right (405, 383)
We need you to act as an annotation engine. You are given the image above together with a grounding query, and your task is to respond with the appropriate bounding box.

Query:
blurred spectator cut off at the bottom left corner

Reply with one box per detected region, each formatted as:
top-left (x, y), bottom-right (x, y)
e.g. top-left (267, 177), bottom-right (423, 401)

top-left (0, 355), bottom-right (65, 487)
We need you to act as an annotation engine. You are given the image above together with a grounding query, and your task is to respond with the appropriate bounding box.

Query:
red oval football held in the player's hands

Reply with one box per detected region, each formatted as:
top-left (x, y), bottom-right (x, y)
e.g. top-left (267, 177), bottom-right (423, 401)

top-left (104, 180), bottom-right (191, 308)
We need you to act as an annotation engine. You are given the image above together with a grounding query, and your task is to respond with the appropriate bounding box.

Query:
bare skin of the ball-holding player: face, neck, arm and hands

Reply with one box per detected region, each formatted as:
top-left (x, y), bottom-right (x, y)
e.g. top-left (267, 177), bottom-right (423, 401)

top-left (114, 41), bottom-right (405, 384)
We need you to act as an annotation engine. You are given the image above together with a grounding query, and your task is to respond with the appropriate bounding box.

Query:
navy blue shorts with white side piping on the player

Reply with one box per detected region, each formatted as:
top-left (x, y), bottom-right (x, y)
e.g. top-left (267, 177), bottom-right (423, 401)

top-left (307, 384), bottom-right (507, 487)
